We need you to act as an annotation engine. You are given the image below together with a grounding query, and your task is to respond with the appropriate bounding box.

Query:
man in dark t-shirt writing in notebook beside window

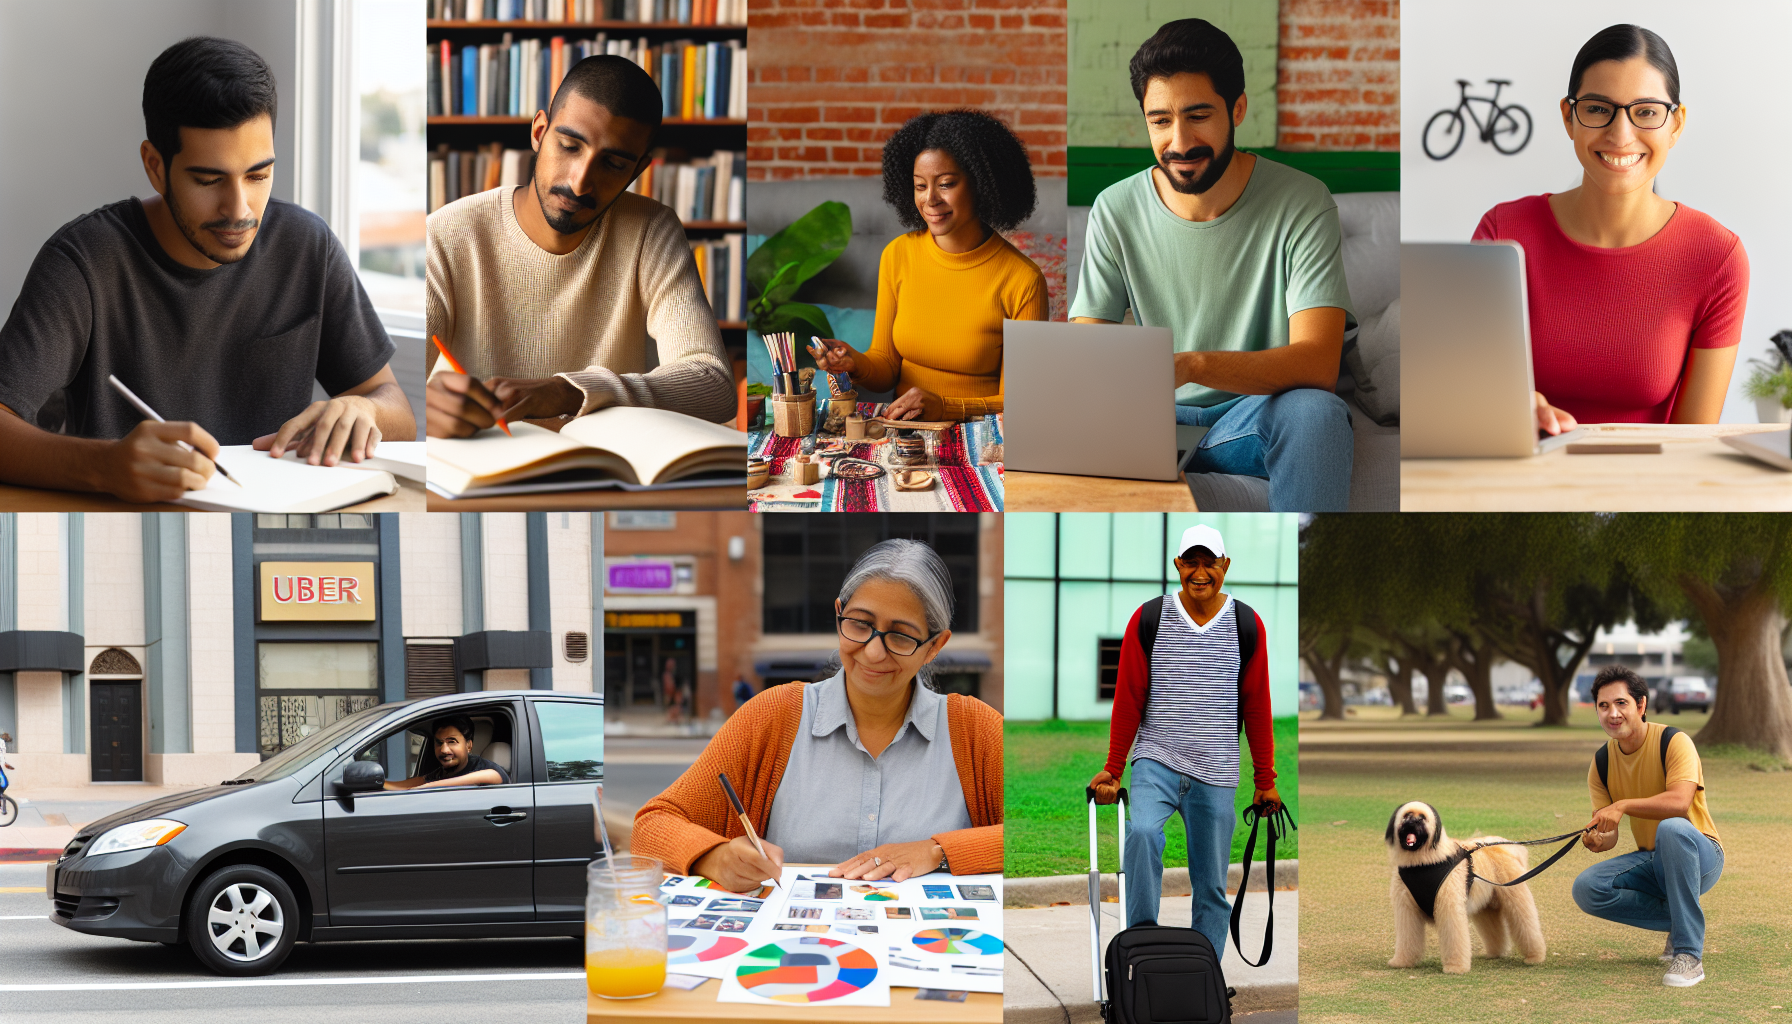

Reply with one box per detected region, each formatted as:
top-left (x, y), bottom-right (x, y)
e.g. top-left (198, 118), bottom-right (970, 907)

top-left (0, 38), bottom-right (416, 500)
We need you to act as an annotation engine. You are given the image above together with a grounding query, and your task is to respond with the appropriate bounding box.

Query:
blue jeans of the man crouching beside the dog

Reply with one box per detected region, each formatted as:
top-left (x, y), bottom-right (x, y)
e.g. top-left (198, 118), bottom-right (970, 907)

top-left (1573, 818), bottom-right (1724, 958)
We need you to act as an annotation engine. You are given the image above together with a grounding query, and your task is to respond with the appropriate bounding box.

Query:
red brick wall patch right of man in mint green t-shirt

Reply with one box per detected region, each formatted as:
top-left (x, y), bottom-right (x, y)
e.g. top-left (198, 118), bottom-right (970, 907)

top-left (1276, 0), bottom-right (1400, 152)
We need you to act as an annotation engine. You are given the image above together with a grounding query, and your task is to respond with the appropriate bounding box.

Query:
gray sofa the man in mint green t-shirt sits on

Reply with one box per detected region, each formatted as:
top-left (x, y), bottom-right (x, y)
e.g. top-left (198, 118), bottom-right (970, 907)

top-left (1068, 192), bottom-right (1400, 511)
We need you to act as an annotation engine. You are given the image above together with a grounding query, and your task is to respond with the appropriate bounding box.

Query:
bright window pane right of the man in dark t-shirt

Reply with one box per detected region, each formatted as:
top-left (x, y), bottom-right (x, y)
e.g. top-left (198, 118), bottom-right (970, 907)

top-left (355, 0), bottom-right (428, 314)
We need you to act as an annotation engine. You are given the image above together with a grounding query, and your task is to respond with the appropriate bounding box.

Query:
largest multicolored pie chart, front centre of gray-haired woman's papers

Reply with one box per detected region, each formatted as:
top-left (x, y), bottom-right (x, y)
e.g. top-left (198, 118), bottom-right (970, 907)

top-left (715, 934), bottom-right (891, 1006)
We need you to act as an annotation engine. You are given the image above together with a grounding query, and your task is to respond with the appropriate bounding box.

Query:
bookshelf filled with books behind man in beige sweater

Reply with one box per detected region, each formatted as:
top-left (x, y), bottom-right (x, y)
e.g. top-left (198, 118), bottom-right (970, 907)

top-left (425, 0), bottom-right (747, 329)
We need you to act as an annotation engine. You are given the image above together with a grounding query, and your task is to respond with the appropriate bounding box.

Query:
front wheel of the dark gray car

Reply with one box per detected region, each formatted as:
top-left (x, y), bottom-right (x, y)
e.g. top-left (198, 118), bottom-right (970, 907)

top-left (186, 864), bottom-right (299, 977)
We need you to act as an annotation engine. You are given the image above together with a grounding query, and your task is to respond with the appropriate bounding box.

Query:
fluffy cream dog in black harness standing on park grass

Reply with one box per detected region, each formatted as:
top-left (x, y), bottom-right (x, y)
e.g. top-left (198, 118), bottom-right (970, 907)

top-left (1387, 800), bottom-right (1545, 974)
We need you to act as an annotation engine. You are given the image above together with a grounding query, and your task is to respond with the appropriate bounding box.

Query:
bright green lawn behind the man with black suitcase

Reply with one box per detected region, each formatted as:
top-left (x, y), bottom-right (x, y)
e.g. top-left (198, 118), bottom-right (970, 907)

top-left (1002, 717), bottom-right (1301, 877)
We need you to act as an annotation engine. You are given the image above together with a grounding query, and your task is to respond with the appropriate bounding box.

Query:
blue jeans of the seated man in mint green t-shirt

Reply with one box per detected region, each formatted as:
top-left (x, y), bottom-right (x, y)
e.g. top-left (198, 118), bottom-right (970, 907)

top-left (1176, 387), bottom-right (1355, 511)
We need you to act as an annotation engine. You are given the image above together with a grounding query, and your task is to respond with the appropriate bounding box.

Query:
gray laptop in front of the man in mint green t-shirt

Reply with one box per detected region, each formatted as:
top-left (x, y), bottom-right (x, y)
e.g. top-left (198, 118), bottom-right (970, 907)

top-left (1002, 319), bottom-right (1188, 481)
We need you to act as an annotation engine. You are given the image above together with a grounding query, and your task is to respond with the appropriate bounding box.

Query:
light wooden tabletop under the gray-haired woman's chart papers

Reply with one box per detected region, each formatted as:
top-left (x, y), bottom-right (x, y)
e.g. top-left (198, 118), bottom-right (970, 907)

top-left (584, 864), bottom-right (1002, 1024)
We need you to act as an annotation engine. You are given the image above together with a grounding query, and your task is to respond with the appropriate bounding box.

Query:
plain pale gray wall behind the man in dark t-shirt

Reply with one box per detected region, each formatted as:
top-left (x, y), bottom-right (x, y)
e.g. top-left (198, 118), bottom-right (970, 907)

top-left (0, 0), bottom-right (297, 321)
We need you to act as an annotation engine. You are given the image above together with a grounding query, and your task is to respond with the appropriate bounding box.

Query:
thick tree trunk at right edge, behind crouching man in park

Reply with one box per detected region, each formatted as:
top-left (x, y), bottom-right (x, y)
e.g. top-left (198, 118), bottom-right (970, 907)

top-left (1677, 577), bottom-right (1792, 760)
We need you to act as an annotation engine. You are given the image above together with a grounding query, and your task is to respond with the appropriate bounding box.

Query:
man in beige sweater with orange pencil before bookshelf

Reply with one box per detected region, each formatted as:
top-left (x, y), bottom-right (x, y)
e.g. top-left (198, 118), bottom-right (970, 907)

top-left (428, 56), bottom-right (735, 438)
